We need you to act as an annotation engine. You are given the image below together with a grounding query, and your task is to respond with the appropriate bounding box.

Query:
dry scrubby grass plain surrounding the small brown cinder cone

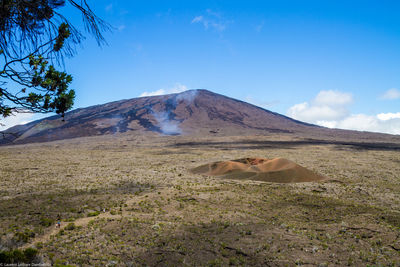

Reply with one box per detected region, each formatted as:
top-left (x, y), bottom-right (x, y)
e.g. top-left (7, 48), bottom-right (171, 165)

top-left (0, 135), bottom-right (400, 266)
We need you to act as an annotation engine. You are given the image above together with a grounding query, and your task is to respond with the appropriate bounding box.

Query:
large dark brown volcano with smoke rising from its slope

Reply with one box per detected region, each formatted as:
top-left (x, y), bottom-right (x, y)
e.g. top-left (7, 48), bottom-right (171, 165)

top-left (1, 89), bottom-right (400, 144)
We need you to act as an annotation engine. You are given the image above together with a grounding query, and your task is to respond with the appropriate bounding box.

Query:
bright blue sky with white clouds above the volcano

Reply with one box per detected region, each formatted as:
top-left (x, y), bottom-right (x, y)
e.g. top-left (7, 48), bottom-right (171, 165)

top-left (0, 0), bottom-right (400, 134)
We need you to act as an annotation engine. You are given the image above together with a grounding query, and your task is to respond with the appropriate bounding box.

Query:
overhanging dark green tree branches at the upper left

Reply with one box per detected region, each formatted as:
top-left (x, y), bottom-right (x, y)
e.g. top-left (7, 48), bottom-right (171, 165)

top-left (0, 0), bottom-right (109, 129)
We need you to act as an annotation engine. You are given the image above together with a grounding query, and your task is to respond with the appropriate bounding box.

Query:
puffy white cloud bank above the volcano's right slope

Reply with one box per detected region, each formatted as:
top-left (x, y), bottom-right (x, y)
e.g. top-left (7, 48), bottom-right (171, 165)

top-left (287, 91), bottom-right (400, 134)
